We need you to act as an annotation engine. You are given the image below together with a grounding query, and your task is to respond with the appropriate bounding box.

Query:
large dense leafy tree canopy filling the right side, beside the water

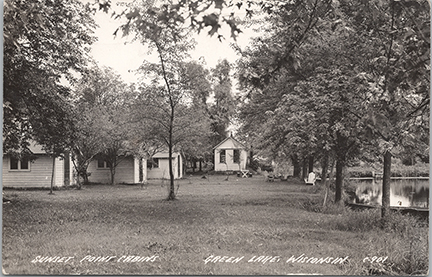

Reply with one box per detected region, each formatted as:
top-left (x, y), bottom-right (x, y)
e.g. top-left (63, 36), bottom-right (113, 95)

top-left (238, 0), bottom-right (430, 211)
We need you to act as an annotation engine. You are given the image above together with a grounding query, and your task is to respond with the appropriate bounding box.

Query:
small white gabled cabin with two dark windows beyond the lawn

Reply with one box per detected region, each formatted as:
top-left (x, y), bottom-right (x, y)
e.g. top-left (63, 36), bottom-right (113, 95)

top-left (213, 136), bottom-right (248, 171)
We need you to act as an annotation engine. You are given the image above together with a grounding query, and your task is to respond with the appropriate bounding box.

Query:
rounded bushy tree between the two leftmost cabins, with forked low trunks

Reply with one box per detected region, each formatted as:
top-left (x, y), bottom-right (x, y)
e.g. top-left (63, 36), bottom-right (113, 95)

top-left (73, 66), bottom-right (134, 184)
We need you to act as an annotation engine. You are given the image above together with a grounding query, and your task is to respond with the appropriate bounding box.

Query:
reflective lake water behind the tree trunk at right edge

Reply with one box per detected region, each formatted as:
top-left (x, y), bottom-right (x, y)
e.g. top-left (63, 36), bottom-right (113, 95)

top-left (350, 179), bottom-right (429, 208)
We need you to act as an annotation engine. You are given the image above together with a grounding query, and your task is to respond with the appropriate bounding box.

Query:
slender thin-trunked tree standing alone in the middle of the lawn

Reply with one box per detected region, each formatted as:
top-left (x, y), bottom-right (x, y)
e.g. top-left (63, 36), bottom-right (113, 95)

top-left (120, 1), bottom-right (212, 200)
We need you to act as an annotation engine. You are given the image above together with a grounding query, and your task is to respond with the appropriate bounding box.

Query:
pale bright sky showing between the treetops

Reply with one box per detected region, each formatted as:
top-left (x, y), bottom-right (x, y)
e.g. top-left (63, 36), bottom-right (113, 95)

top-left (91, 0), bottom-right (255, 83)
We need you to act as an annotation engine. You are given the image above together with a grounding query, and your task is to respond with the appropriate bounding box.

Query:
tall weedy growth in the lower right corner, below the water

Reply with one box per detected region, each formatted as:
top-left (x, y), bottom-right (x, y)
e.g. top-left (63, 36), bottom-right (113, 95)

top-left (329, 209), bottom-right (429, 275)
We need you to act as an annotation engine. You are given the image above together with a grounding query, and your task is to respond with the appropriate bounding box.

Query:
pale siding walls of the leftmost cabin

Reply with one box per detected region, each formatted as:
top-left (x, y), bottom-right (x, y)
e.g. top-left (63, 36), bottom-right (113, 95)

top-left (2, 155), bottom-right (64, 187)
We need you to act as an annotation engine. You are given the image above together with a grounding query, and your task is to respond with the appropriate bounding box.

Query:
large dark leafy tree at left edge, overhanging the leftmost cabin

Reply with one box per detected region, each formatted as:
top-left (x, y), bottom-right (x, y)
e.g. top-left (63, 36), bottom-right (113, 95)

top-left (3, 0), bottom-right (95, 155)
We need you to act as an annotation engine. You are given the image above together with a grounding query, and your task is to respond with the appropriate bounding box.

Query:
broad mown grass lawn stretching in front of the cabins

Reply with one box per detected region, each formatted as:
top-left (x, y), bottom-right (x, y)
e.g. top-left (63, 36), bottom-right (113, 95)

top-left (2, 176), bottom-right (427, 275)
